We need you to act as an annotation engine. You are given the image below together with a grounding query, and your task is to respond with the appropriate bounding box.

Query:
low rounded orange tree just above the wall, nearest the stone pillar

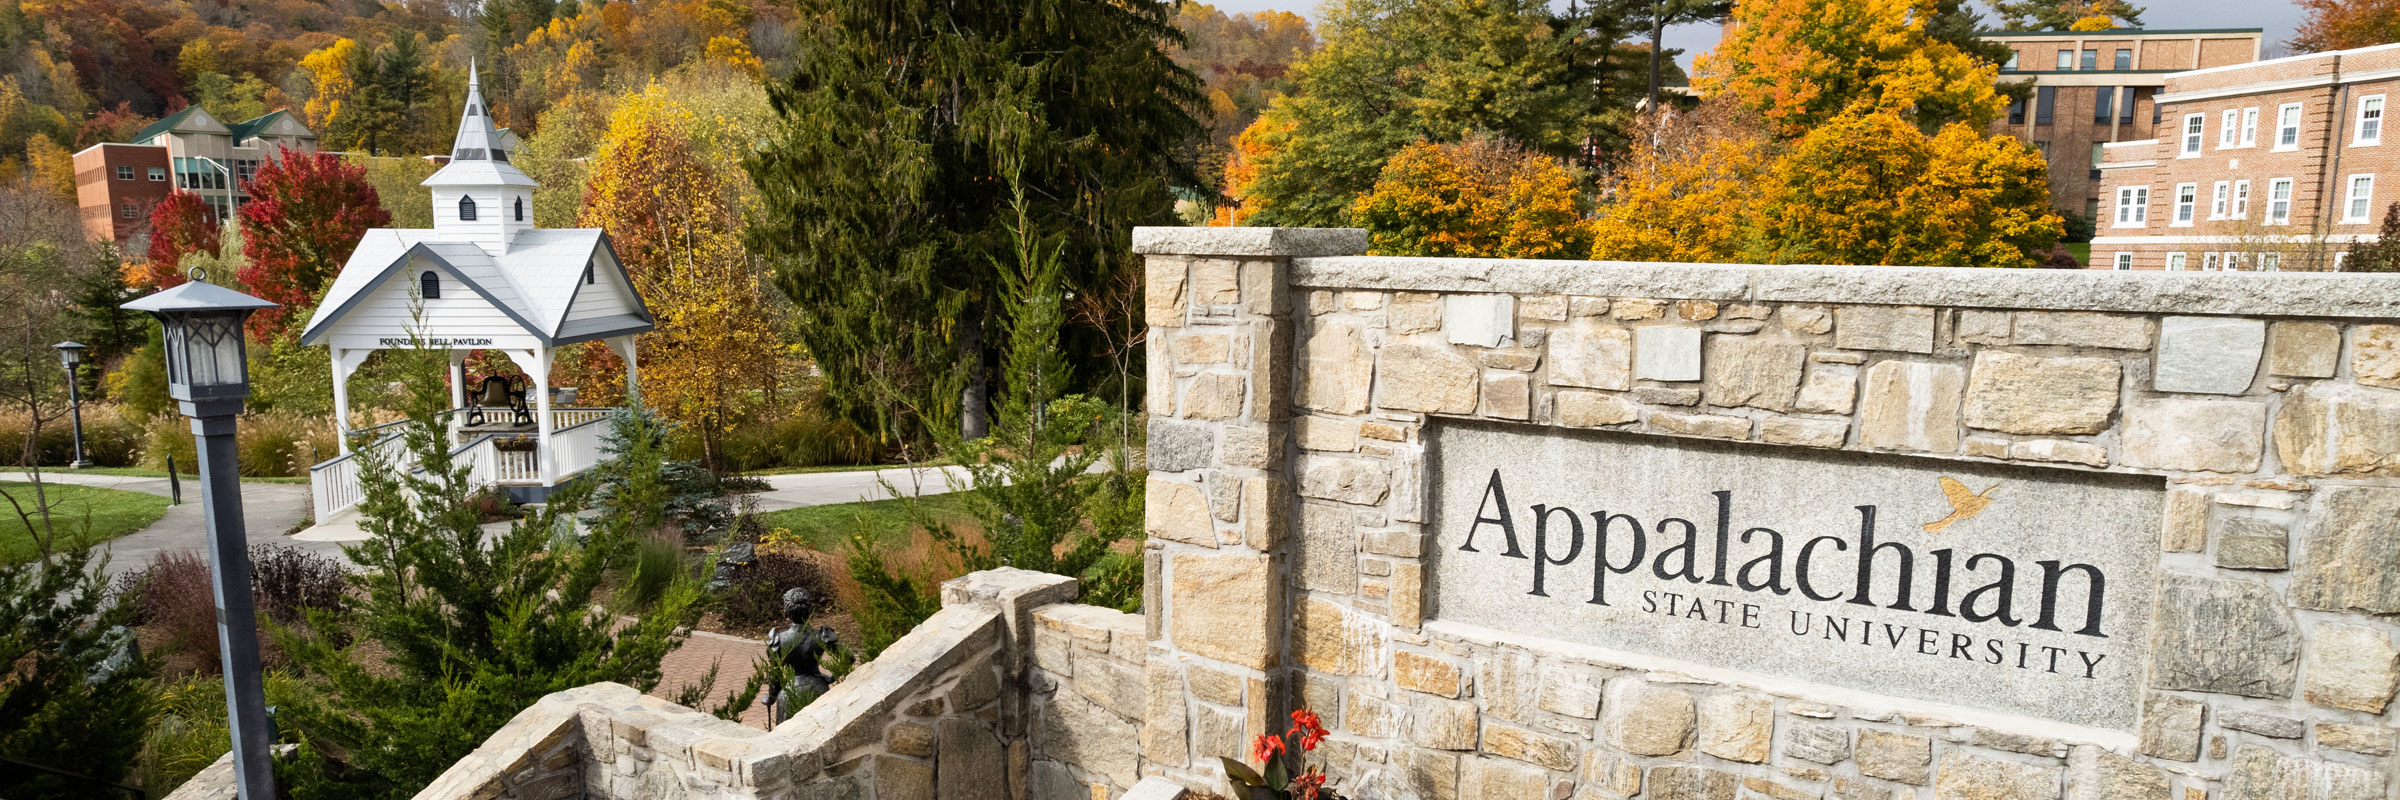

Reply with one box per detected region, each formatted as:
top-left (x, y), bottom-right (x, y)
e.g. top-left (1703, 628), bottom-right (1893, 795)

top-left (1351, 137), bottom-right (1591, 259)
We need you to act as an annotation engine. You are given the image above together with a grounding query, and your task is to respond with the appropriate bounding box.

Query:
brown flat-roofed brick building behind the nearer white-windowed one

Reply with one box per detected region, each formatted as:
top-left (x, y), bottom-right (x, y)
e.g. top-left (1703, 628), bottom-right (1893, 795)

top-left (1982, 29), bottom-right (2261, 219)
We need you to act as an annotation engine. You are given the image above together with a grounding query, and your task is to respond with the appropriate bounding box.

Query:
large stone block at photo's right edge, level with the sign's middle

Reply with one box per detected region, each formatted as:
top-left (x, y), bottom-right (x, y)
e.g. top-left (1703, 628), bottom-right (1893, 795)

top-left (2292, 485), bottom-right (2400, 615)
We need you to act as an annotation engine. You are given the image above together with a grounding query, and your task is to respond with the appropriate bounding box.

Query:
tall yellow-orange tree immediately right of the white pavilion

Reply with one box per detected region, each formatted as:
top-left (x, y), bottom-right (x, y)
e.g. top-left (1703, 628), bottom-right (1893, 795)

top-left (581, 84), bottom-right (787, 466)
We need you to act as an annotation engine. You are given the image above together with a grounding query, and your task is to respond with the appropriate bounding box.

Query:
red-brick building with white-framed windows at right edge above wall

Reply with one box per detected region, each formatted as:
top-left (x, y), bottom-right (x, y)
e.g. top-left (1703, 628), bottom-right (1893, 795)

top-left (2093, 46), bottom-right (2400, 271)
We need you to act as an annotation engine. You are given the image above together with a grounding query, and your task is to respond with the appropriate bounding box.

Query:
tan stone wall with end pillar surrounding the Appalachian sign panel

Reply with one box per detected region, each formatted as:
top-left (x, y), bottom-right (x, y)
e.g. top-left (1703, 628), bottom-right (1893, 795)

top-left (1132, 228), bottom-right (2400, 800)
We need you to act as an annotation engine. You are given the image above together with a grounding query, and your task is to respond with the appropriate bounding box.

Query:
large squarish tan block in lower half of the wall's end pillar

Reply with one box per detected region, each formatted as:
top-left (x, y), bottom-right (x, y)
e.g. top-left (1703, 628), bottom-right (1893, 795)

top-left (1166, 547), bottom-right (1282, 670)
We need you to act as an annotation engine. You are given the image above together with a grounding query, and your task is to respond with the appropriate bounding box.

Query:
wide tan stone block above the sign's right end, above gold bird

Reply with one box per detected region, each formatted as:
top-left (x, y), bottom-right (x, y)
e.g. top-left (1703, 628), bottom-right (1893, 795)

top-left (1966, 351), bottom-right (2119, 435)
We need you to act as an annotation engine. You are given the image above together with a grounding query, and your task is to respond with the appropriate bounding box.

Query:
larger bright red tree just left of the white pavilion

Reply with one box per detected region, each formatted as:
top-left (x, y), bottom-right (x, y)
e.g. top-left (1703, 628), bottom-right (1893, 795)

top-left (238, 149), bottom-right (391, 339)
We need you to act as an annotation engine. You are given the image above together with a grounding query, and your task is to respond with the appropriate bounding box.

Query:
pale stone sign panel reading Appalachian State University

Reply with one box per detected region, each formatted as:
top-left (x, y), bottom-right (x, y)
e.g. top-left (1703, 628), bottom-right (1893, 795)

top-left (1430, 423), bottom-right (2162, 730)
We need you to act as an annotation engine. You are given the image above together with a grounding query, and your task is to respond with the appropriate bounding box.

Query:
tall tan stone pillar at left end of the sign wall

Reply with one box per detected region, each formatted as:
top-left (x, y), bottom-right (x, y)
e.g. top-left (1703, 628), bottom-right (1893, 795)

top-left (1133, 228), bottom-right (1368, 788)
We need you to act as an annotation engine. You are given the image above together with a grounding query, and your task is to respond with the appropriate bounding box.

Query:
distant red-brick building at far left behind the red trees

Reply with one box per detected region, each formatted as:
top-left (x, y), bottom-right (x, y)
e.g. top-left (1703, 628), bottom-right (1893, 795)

top-left (74, 106), bottom-right (317, 257)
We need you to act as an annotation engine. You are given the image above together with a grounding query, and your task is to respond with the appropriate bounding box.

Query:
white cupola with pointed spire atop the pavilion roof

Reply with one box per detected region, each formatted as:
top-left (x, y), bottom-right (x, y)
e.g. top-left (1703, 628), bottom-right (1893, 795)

top-left (425, 65), bottom-right (535, 255)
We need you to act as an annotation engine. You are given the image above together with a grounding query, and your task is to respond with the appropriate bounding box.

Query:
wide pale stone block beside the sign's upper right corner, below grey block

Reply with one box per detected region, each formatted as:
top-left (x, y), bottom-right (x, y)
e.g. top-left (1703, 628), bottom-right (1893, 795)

top-left (2122, 399), bottom-right (2266, 473)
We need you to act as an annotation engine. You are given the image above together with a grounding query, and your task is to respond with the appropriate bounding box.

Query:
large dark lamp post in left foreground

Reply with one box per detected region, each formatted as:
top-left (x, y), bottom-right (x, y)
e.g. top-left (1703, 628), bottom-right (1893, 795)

top-left (125, 269), bottom-right (276, 800)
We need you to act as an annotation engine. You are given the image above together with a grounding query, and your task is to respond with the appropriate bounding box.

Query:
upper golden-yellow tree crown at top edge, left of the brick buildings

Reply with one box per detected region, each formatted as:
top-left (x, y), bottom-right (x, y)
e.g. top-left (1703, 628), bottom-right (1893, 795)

top-left (1692, 0), bottom-right (2006, 137)
